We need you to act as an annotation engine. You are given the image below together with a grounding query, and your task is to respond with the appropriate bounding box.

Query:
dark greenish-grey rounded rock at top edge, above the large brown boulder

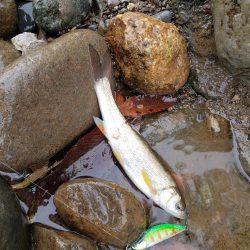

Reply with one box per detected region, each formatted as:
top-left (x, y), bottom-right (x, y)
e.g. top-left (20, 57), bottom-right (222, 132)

top-left (33, 0), bottom-right (92, 34)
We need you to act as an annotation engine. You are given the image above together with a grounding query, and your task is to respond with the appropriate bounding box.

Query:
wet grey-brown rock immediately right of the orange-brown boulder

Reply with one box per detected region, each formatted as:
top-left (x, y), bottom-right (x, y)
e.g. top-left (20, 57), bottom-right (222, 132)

top-left (191, 56), bottom-right (234, 98)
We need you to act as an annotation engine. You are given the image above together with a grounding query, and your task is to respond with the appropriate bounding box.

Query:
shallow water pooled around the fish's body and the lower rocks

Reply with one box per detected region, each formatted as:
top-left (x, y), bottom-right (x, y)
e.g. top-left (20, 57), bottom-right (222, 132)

top-left (4, 106), bottom-right (250, 250)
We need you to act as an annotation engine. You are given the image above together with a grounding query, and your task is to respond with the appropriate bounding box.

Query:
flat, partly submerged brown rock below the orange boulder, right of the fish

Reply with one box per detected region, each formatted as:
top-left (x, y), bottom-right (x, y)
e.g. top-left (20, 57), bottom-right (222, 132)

top-left (141, 104), bottom-right (232, 151)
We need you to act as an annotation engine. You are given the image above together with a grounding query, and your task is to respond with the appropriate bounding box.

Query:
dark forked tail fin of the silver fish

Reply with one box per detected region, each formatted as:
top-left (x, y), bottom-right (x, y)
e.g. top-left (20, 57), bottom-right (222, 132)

top-left (89, 44), bottom-right (112, 84)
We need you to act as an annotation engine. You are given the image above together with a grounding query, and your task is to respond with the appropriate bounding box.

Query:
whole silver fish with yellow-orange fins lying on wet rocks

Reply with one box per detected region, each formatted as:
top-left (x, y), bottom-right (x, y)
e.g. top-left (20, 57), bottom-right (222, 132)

top-left (89, 45), bottom-right (186, 219)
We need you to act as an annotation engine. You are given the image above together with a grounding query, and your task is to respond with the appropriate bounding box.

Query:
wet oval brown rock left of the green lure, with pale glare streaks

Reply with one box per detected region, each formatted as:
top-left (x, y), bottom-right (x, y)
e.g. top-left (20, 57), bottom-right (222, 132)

top-left (54, 178), bottom-right (146, 248)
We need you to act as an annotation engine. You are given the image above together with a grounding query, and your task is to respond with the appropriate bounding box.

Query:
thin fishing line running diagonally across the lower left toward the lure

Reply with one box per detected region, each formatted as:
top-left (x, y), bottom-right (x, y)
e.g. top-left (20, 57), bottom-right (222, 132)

top-left (0, 161), bottom-right (124, 244)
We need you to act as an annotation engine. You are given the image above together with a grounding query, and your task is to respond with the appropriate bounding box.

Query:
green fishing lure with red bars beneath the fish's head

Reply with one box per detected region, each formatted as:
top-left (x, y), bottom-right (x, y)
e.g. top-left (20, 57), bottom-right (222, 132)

top-left (126, 224), bottom-right (187, 250)
